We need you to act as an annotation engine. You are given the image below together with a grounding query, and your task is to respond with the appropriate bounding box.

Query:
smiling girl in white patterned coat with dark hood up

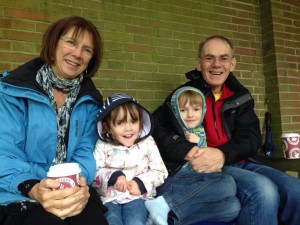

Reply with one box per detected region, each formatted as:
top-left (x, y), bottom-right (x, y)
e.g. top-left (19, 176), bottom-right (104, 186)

top-left (93, 94), bottom-right (168, 225)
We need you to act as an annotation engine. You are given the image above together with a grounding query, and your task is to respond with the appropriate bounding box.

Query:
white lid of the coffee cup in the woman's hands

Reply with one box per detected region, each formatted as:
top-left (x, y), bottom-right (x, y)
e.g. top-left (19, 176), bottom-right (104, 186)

top-left (47, 163), bottom-right (81, 177)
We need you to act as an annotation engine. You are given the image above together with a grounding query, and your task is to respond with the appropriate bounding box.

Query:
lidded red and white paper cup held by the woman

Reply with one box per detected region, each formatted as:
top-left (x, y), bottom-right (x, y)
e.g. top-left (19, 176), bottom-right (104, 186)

top-left (47, 163), bottom-right (81, 189)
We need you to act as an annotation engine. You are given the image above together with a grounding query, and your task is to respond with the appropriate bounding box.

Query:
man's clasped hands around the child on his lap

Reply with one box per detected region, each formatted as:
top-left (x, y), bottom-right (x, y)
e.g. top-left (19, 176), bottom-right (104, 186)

top-left (188, 147), bottom-right (225, 173)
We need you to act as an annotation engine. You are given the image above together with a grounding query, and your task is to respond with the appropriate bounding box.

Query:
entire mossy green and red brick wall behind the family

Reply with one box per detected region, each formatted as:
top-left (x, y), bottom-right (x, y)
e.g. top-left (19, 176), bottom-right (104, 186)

top-left (0, 0), bottom-right (300, 156)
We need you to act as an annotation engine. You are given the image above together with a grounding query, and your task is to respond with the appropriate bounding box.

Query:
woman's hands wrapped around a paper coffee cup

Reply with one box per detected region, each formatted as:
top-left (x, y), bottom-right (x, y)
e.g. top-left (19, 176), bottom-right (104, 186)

top-left (28, 177), bottom-right (89, 219)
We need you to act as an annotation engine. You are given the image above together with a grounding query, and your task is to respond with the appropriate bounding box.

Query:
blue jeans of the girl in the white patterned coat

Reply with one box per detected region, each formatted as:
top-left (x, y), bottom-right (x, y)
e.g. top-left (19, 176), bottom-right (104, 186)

top-left (105, 199), bottom-right (148, 225)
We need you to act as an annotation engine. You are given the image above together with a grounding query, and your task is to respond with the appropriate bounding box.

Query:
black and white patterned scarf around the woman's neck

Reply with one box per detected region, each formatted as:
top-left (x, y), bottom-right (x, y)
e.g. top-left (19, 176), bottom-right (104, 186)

top-left (36, 64), bottom-right (83, 165)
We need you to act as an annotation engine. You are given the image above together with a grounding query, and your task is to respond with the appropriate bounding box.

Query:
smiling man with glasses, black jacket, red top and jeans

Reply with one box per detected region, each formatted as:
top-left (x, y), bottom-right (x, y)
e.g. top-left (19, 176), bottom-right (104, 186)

top-left (153, 36), bottom-right (300, 225)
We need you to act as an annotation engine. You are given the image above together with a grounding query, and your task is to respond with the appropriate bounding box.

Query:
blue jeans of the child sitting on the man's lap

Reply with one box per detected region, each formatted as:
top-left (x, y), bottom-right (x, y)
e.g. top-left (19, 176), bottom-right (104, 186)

top-left (158, 168), bottom-right (240, 225)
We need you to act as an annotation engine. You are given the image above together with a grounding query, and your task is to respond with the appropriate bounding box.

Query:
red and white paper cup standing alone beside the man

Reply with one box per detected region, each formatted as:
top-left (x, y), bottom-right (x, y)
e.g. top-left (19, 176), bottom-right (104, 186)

top-left (281, 133), bottom-right (300, 159)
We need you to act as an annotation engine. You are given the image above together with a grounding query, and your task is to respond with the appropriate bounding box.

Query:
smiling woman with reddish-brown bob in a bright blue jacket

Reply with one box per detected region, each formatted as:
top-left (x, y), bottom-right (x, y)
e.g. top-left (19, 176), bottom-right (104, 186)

top-left (0, 16), bottom-right (107, 225)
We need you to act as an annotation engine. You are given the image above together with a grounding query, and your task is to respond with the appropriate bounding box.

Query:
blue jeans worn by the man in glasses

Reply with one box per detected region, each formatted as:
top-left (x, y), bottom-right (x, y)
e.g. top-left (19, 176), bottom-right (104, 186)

top-left (223, 162), bottom-right (300, 225)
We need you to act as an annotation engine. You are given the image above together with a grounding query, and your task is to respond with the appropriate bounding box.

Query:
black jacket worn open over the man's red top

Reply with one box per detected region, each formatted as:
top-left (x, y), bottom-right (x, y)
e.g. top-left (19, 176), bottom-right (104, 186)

top-left (153, 70), bottom-right (261, 174)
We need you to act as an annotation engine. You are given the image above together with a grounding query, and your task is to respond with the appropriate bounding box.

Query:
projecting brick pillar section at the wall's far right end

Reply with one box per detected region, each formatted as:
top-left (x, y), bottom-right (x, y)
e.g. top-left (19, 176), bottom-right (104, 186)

top-left (260, 0), bottom-right (300, 154)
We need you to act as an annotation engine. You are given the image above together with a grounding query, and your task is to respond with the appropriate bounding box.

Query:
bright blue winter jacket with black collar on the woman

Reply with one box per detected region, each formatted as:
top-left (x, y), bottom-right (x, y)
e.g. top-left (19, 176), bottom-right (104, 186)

top-left (0, 58), bottom-right (102, 205)
